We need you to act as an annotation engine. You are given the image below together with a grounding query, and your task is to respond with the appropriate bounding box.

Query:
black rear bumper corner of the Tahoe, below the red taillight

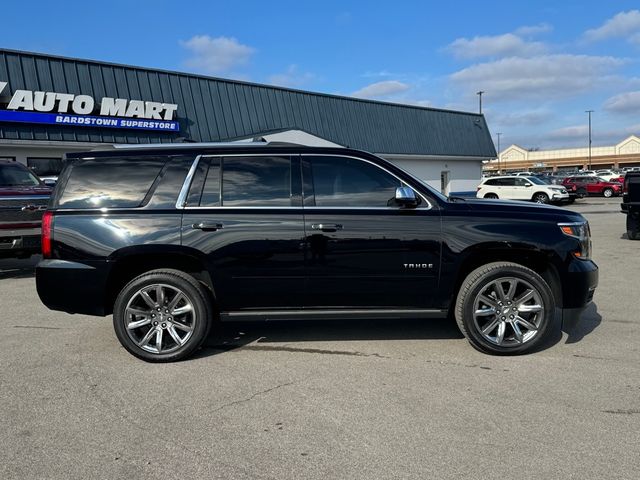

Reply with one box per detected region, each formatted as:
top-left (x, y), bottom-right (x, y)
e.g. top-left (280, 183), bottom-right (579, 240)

top-left (36, 260), bottom-right (106, 316)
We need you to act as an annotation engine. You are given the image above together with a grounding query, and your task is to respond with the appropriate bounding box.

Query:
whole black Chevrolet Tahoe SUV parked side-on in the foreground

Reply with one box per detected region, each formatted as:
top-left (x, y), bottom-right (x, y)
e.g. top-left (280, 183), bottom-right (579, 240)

top-left (37, 143), bottom-right (598, 361)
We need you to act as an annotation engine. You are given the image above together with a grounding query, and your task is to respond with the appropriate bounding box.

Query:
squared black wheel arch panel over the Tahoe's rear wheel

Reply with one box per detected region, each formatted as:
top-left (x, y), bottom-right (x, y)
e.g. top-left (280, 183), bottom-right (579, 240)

top-left (105, 245), bottom-right (216, 315)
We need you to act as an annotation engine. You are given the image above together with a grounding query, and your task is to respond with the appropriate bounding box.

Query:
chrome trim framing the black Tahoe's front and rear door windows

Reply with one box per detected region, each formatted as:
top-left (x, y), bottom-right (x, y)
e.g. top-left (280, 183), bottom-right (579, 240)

top-left (176, 152), bottom-right (433, 211)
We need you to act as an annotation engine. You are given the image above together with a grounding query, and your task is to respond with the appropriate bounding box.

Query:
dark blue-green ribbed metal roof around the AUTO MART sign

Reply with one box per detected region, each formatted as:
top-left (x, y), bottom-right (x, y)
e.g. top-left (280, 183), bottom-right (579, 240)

top-left (0, 49), bottom-right (496, 158)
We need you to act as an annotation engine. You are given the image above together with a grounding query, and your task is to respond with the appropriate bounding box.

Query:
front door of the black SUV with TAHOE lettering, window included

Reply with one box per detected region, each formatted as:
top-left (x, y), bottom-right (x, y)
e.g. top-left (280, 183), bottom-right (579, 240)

top-left (302, 155), bottom-right (441, 309)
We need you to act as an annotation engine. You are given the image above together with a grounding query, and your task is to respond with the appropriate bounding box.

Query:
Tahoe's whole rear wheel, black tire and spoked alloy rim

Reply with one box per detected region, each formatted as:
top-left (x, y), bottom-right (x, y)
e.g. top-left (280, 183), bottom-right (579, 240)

top-left (113, 270), bottom-right (212, 362)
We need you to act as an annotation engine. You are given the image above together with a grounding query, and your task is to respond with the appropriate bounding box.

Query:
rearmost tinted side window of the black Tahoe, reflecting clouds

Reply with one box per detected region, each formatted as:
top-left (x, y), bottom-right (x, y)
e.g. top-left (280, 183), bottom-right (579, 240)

top-left (57, 157), bottom-right (167, 208)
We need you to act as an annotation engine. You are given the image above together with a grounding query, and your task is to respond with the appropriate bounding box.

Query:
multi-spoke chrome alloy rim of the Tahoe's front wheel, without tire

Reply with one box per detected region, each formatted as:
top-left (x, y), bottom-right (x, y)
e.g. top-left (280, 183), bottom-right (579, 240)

top-left (473, 277), bottom-right (544, 347)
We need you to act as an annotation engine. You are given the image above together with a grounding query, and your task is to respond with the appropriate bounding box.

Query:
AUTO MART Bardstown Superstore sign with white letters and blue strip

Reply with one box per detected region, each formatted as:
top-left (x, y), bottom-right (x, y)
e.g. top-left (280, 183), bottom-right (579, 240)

top-left (0, 82), bottom-right (180, 131)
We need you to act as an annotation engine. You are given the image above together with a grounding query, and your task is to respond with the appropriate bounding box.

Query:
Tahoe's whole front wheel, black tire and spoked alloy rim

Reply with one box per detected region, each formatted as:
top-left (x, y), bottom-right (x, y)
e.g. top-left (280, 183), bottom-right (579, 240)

top-left (455, 262), bottom-right (555, 355)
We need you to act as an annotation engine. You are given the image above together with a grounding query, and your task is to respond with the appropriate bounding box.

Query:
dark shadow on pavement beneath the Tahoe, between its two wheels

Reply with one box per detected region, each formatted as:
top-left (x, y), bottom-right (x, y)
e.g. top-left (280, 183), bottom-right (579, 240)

top-left (196, 318), bottom-right (463, 357)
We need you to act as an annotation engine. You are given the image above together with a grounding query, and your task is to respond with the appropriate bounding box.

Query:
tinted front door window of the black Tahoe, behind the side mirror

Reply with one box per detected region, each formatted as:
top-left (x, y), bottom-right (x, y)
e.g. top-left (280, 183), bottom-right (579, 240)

top-left (311, 157), bottom-right (402, 207)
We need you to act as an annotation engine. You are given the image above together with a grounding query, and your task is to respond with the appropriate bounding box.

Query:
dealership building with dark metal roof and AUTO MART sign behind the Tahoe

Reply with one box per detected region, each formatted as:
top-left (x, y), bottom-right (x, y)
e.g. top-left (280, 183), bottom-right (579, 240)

top-left (0, 49), bottom-right (496, 191)
